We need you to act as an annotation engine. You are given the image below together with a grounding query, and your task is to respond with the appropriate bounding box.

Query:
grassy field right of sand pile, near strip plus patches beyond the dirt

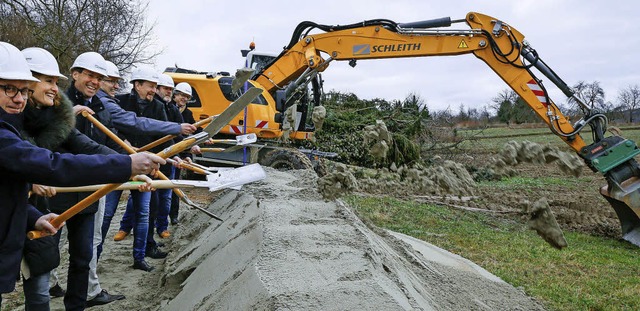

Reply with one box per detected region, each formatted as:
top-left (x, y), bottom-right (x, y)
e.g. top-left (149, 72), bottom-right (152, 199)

top-left (345, 126), bottom-right (640, 310)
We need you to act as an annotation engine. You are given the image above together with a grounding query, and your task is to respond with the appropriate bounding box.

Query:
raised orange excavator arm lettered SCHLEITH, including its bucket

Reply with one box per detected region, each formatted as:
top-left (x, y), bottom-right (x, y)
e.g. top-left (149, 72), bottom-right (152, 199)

top-left (253, 12), bottom-right (640, 246)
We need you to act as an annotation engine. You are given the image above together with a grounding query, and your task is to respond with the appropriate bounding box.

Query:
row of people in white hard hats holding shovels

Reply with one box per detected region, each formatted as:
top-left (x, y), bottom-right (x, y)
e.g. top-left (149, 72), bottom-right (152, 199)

top-left (0, 42), bottom-right (199, 310)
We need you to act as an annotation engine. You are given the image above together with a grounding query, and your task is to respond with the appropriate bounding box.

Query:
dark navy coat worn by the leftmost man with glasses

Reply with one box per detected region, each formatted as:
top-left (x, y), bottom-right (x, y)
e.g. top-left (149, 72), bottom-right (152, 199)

top-left (0, 109), bottom-right (131, 293)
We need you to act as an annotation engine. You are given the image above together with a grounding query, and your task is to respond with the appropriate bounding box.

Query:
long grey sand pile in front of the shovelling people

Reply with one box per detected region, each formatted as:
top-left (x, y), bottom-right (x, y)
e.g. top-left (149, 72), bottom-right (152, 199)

top-left (154, 169), bottom-right (542, 310)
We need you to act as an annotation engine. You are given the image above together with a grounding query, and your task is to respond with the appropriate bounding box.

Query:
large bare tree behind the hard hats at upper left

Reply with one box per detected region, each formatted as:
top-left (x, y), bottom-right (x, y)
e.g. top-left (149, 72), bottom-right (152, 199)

top-left (0, 0), bottom-right (161, 72)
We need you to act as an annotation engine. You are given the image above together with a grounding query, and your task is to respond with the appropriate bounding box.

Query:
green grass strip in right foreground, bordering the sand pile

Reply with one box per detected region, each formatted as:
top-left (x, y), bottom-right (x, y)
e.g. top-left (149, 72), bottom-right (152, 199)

top-left (345, 196), bottom-right (640, 311)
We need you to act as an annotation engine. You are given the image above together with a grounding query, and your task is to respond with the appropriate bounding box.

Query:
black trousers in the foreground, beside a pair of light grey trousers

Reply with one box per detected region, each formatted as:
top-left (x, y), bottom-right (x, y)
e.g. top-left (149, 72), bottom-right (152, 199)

top-left (56, 213), bottom-right (94, 310)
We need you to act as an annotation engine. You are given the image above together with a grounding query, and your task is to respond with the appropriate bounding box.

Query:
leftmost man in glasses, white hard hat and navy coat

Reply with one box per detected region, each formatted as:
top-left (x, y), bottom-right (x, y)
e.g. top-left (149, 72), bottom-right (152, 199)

top-left (0, 42), bottom-right (165, 308)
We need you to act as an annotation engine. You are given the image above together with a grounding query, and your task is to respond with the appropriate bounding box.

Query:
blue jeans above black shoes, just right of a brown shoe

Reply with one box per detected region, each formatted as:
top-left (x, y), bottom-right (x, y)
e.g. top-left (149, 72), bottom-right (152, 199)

top-left (120, 190), bottom-right (151, 261)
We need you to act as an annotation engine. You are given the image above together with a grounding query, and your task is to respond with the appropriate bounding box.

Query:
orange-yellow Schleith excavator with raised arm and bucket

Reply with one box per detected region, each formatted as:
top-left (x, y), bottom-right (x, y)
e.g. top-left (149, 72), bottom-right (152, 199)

top-left (169, 12), bottom-right (640, 246)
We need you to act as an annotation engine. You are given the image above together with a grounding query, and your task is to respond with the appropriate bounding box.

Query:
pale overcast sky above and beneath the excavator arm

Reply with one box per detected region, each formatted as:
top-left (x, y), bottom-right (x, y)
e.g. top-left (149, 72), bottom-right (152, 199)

top-left (149, 0), bottom-right (640, 112)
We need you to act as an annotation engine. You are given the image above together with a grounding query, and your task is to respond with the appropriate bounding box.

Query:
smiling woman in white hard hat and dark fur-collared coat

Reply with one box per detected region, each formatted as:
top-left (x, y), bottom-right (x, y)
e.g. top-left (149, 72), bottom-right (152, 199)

top-left (22, 47), bottom-right (138, 310)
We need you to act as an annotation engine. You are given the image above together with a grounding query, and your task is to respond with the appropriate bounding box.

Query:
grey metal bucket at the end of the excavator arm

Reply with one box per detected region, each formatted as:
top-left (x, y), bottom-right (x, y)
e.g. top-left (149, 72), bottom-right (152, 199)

top-left (600, 177), bottom-right (640, 246)
